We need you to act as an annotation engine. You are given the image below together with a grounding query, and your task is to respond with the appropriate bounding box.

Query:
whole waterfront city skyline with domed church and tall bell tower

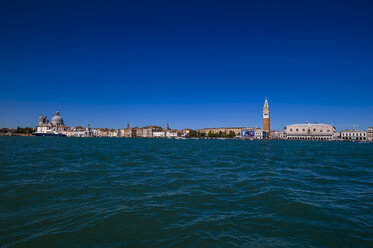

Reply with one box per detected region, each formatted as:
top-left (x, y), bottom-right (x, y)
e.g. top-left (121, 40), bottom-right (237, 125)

top-left (5, 100), bottom-right (366, 142)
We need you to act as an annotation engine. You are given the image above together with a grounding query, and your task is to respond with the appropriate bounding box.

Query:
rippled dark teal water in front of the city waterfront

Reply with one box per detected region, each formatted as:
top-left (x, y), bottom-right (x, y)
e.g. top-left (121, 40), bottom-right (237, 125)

top-left (0, 137), bottom-right (373, 247)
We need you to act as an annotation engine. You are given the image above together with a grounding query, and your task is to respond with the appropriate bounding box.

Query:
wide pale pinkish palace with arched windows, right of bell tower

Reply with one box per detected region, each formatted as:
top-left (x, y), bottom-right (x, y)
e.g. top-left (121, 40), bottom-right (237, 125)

top-left (285, 122), bottom-right (336, 140)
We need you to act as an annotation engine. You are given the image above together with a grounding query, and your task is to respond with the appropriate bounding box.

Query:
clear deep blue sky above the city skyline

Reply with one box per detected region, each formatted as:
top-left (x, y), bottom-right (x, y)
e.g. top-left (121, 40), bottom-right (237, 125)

top-left (0, 0), bottom-right (373, 130)
